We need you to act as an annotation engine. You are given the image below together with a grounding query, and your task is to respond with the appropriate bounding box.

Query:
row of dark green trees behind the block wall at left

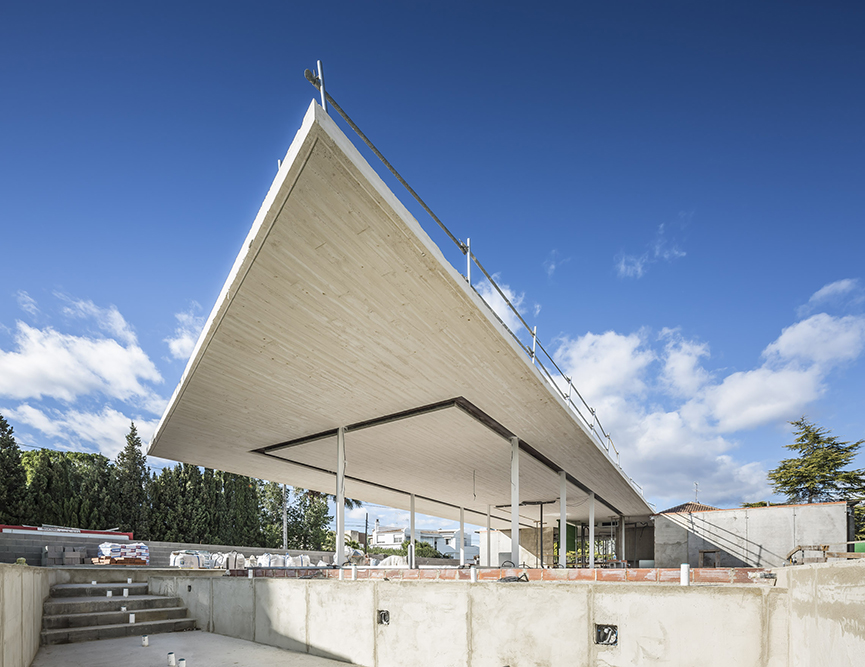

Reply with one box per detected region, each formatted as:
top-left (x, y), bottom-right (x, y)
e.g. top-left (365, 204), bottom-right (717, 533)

top-left (0, 415), bottom-right (333, 550)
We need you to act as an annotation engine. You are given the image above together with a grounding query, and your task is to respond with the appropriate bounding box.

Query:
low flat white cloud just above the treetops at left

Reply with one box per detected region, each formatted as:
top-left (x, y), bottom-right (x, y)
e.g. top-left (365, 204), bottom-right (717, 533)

top-left (4, 403), bottom-right (158, 458)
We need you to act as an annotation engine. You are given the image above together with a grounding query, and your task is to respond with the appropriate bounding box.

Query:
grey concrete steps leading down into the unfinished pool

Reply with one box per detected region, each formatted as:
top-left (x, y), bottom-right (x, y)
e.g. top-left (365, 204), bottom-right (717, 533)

top-left (42, 583), bottom-right (195, 644)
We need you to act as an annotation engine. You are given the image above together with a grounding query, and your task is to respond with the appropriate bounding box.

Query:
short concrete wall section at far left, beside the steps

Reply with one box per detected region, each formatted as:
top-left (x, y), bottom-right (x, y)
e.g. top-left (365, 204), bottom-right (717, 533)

top-left (0, 563), bottom-right (52, 667)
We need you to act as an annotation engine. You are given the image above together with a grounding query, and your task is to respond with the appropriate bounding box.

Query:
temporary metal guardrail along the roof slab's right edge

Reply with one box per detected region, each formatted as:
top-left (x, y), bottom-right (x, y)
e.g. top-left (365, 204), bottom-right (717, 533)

top-left (304, 69), bottom-right (643, 496)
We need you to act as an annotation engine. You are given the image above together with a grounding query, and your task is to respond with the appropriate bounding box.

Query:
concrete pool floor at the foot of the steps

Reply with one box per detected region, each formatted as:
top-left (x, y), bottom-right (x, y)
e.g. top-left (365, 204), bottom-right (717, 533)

top-left (31, 632), bottom-right (346, 667)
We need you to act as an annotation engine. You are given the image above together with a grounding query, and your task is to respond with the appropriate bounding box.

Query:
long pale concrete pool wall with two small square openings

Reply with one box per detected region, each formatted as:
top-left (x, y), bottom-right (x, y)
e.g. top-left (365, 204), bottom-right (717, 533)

top-left (151, 567), bottom-right (816, 667)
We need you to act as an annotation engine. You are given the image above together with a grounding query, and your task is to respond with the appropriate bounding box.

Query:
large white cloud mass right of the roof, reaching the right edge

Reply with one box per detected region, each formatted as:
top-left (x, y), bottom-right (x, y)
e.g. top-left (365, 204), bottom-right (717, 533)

top-left (556, 314), bottom-right (865, 508)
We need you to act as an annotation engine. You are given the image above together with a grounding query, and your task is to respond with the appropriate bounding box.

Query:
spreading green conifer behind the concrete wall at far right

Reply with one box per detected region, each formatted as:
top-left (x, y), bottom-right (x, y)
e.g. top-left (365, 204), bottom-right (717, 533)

top-left (769, 417), bottom-right (865, 503)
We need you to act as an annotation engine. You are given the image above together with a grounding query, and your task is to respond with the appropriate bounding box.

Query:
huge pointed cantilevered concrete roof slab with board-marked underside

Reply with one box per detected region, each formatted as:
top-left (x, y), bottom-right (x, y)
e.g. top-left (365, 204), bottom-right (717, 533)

top-left (149, 102), bottom-right (651, 528)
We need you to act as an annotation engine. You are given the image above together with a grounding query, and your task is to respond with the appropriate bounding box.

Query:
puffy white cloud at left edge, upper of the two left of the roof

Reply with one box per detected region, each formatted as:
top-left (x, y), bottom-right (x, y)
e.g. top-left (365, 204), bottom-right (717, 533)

top-left (0, 320), bottom-right (162, 402)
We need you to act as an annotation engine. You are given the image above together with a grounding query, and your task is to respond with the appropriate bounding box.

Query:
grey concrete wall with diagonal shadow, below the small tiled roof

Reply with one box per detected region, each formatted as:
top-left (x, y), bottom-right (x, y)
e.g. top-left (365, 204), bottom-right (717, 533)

top-left (655, 502), bottom-right (847, 567)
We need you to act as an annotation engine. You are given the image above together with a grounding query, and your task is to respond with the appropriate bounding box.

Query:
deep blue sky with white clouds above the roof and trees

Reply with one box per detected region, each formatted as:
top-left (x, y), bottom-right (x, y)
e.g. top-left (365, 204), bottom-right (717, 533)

top-left (0, 1), bottom-right (865, 525)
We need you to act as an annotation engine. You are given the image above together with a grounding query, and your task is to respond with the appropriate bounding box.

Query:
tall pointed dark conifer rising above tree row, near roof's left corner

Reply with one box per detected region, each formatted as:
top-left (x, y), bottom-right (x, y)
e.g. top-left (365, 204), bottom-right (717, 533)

top-left (114, 422), bottom-right (150, 540)
